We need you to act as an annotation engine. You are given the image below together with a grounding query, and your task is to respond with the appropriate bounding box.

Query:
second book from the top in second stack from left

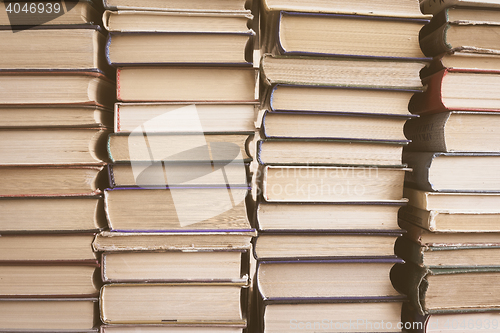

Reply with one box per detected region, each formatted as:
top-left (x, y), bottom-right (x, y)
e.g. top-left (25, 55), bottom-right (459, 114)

top-left (102, 10), bottom-right (253, 33)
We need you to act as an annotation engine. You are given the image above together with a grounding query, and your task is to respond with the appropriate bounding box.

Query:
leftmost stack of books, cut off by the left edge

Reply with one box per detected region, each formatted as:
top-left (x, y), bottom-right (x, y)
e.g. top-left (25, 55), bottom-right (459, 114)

top-left (0, 1), bottom-right (111, 332)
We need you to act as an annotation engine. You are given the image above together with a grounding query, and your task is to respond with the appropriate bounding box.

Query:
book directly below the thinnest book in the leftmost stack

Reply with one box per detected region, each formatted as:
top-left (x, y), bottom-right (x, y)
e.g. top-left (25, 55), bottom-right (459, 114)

top-left (0, 128), bottom-right (110, 165)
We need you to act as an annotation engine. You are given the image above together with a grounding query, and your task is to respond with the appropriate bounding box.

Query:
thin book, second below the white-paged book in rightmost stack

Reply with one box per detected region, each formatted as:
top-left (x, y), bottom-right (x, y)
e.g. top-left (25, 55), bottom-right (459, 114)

top-left (398, 205), bottom-right (500, 232)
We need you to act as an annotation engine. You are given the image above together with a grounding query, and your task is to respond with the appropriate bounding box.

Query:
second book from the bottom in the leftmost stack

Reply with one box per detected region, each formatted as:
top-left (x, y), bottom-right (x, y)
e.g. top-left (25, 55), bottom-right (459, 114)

top-left (0, 263), bottom-right (100, 298)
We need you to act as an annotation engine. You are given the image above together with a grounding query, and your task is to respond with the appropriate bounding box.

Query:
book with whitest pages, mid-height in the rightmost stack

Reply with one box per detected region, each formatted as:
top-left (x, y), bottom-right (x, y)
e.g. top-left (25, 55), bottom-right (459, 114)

top-left (403, 152), bottom-right (500, 192)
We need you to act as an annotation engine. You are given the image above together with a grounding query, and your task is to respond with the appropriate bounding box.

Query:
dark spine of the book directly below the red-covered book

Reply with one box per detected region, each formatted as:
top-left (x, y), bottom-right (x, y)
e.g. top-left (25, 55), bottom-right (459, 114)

top-left (404, 112), bottom-right (451, 152)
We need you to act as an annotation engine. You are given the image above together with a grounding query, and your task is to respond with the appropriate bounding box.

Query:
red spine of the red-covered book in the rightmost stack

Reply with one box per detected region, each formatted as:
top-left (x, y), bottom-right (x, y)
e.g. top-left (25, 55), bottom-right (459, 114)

top-left (408, 69), bottom-right (448, 114)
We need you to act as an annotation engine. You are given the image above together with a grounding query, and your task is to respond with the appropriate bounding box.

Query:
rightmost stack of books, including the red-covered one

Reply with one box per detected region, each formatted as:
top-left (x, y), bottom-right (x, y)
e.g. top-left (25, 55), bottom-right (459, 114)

top-left (393, 1), bottom-right (500, 332)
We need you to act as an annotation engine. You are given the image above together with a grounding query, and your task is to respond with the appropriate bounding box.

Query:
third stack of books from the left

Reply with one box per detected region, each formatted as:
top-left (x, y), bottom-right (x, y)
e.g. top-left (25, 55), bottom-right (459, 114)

top-left (255, 0), bottom-right (429, 332)
